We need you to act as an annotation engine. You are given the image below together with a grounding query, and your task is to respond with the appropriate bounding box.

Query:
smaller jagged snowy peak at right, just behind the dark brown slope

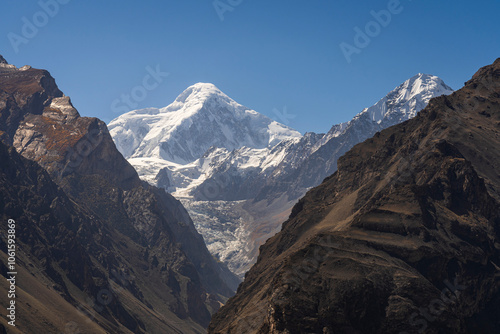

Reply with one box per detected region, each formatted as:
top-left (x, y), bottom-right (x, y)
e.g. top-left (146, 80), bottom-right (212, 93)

top-left (361, 73), bottom-right (453, 123)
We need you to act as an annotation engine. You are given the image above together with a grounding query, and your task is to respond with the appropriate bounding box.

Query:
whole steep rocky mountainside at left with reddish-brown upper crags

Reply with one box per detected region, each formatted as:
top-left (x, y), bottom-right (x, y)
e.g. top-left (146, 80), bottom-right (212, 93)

top-left (0, 57), bottom-right (239, 333)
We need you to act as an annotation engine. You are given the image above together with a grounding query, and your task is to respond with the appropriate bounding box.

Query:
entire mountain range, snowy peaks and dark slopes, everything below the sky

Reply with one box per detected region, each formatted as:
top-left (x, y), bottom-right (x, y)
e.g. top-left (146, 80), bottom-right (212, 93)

top-left (0, 52), bottom-right (500, 334)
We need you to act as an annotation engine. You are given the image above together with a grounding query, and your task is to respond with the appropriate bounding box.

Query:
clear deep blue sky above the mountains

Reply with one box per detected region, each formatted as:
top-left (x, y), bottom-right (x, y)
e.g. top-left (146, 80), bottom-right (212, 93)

top-left (0, 0), bottom-right (500, 133)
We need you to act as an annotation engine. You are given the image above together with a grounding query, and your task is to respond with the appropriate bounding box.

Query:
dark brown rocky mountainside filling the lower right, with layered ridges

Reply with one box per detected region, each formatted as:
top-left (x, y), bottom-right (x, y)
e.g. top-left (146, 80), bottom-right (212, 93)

top-left (209, 59), bottom-right (500, 333)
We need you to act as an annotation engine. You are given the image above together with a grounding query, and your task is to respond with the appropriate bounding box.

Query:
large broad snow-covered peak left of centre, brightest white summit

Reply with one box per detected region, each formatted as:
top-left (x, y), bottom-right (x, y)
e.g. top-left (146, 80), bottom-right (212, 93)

top-left (109, 83), bottom-right (301, 164)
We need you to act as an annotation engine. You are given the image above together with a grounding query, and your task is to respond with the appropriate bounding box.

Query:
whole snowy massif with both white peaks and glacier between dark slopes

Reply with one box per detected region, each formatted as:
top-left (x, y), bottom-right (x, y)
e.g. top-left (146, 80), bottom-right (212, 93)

top-left (109, 74), bottom-right (452, 277)
